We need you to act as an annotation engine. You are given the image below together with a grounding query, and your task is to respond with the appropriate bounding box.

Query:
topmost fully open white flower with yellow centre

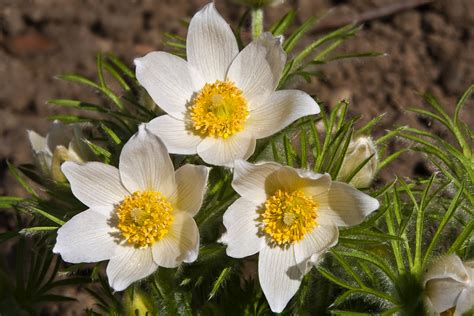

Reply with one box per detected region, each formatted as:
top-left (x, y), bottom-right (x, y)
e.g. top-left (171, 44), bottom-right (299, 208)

top-left (135, 3), bottom-right (319, 166)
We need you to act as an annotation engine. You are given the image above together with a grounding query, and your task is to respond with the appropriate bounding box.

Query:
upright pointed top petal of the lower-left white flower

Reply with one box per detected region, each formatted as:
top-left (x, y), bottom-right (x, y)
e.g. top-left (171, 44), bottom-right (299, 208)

top-left (119, 124), bottom-right (175, 196)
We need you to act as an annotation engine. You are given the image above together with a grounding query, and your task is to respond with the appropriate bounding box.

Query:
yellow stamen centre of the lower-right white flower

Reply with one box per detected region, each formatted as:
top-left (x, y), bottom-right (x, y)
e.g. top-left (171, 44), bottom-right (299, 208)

top-left (259, 190), bottom-right (319, 246)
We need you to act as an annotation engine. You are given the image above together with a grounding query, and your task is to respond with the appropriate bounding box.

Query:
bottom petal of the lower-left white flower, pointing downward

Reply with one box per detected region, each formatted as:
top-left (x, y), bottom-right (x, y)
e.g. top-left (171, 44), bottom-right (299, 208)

top-left (106, 245), bottom-right (158, 291)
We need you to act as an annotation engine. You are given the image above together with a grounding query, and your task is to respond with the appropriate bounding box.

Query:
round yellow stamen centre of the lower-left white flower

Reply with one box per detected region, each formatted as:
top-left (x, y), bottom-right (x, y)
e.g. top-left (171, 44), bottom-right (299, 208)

top-left (115, 191), bottom-right (174, 248)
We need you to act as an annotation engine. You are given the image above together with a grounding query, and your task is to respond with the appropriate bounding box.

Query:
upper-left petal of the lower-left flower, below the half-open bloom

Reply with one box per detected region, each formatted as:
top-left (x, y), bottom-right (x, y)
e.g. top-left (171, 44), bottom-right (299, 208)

top-left (61, 161), bottom-right (130, 207)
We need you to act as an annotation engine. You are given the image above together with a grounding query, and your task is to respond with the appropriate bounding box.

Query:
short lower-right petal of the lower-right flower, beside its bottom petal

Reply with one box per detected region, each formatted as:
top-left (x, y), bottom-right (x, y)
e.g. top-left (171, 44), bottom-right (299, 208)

top-left (294, 220), bottom-right (339, 274)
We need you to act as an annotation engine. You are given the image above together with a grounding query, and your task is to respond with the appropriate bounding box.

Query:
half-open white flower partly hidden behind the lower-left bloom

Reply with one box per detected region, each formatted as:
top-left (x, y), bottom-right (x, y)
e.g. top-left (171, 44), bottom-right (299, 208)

top-left (28, 121), bottom-right (93, 181)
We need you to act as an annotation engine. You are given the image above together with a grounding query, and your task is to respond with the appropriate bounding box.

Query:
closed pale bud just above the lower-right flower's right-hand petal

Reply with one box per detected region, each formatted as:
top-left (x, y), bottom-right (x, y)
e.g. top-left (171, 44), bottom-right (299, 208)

top-left (337, 137), bottom-right (378, 188)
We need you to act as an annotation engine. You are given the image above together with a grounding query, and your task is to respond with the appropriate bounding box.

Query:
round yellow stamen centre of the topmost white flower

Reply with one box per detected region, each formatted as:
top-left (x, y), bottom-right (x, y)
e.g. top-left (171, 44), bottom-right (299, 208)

top-left (190, 80), bottom-right (249, 138)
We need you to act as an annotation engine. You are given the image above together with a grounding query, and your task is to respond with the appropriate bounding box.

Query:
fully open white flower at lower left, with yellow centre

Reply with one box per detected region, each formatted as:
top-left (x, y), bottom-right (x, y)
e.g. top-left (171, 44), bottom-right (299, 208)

top-left (53, 125), bottom-right (208, 291)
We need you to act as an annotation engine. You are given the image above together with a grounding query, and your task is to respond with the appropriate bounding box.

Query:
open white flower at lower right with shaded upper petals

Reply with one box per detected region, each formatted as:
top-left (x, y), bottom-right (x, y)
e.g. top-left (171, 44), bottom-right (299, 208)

top-left (221, 160), bottom-right (379, 312)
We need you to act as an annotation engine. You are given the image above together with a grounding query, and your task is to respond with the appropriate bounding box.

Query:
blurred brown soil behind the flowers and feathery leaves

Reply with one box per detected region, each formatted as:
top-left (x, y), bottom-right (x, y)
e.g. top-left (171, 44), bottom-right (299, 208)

top-left (0, 0), bottom-right (474, 315)
